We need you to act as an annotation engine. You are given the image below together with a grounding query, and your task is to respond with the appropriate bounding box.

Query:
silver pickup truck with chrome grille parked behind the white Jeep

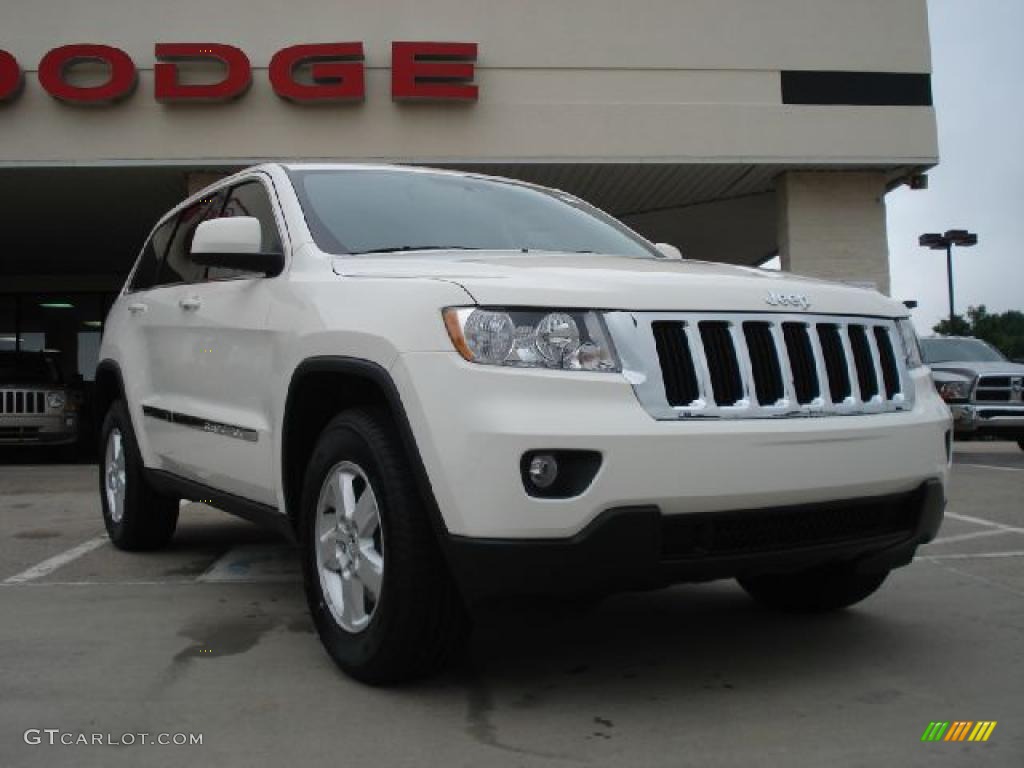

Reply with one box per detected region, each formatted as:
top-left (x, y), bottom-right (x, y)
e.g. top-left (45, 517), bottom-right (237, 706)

top-left (922, 336), bottom-right (1024, 451)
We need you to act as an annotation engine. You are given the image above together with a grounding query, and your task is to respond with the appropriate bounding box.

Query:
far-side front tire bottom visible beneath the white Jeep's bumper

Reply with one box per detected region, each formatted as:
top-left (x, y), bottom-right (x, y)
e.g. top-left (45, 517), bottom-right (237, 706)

top-left (736, 563), bottom-right (889, 613)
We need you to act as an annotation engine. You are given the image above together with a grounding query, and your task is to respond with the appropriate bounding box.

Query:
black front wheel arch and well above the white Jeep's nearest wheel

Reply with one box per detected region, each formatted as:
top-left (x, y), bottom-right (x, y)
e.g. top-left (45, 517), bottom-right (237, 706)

top-left (281, 355), bottom-right (446, 535)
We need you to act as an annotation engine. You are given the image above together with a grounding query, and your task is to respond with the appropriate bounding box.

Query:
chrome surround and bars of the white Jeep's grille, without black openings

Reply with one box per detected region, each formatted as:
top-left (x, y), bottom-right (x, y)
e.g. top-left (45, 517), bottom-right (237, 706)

top-left (604, 311), bottom-right (913, 421)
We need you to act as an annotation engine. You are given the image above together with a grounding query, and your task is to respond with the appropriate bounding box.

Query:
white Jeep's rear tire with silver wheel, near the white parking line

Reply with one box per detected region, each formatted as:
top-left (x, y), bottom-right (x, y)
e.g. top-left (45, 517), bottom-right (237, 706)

top-left (99, 400), bottom-right (178, 551)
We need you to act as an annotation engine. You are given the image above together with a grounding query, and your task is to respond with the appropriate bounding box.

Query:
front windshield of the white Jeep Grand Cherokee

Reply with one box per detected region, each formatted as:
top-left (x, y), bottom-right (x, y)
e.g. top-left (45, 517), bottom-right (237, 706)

top-left (290, 169), bottom-right (658, 258)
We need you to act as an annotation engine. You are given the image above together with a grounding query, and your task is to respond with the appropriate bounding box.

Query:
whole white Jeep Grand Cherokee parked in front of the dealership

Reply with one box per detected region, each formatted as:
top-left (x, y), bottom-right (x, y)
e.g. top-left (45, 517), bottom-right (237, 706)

top-left (96, 165), bottom-right (950, 683)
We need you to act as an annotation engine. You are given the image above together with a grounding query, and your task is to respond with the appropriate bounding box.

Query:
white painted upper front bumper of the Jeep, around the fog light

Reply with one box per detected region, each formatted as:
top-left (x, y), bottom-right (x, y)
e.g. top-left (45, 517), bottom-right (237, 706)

top-left (391, 351), bottom-right (950, 540)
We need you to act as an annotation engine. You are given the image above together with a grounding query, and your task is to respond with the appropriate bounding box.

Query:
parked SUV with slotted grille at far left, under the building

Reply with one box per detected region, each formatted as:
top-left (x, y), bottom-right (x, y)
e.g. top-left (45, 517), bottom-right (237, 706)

top-left (0, 351), bottom-right (78, 445)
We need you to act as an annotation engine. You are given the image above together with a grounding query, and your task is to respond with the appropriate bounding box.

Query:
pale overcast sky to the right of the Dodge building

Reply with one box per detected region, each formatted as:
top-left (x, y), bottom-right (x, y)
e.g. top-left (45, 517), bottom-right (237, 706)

top-left (886, 0), bottom-right (1024, 335)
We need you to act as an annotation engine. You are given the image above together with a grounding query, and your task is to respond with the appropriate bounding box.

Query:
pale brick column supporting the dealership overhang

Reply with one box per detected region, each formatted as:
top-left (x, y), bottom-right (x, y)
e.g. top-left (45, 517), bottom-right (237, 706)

top-left (776, 171), bottom-right (889, 294)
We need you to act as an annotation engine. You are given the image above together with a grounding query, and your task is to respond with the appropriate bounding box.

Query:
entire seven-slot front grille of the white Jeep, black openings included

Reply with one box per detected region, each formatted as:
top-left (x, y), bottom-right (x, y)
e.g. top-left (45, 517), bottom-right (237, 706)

top-left (607, 312), bottom-right (912, 419)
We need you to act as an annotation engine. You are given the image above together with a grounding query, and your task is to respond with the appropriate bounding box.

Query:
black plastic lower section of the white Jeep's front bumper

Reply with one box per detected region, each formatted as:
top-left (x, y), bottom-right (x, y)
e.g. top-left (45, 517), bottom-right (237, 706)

top-left (445, 480), bottom-right (945, 603)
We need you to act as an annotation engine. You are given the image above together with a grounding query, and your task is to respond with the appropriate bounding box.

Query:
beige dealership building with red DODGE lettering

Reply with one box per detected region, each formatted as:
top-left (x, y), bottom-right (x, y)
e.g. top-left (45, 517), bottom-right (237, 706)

top-left (0, 0), bottom-right (937, 380)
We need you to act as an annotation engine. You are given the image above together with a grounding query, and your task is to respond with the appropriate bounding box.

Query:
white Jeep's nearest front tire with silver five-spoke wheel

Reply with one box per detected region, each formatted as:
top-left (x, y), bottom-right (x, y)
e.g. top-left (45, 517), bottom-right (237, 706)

top-left (300, 409), bottom-right (468, 685)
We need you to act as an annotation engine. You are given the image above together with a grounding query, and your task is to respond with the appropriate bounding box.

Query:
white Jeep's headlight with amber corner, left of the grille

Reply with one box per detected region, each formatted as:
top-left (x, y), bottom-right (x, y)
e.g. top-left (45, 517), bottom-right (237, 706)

top-left (443, 307), bottom-right (622, 372)
